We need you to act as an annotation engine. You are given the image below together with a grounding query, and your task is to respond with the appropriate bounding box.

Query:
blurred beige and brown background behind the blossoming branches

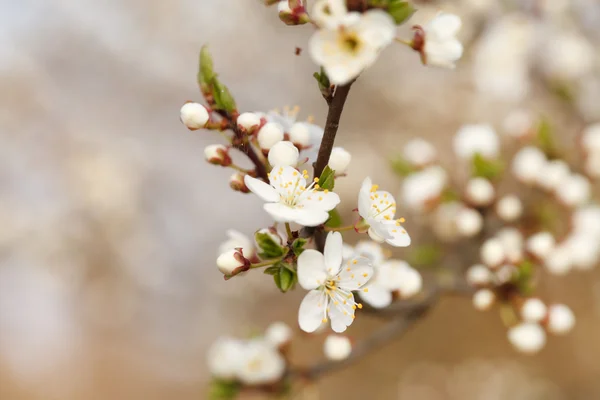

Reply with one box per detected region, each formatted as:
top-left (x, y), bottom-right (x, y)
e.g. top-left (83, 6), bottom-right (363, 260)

top-left (0, 0), bottom-right (600, 400)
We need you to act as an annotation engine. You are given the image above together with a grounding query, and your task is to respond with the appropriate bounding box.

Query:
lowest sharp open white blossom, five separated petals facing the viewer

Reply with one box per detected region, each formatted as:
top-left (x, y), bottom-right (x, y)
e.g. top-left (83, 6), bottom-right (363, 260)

top-left (298, 232), bottom-right (373, 333)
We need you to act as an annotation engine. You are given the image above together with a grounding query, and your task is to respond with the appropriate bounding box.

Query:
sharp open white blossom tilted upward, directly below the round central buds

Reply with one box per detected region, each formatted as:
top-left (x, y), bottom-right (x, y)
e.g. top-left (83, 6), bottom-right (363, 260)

top-left (244, 166), bottom-right (340, 226)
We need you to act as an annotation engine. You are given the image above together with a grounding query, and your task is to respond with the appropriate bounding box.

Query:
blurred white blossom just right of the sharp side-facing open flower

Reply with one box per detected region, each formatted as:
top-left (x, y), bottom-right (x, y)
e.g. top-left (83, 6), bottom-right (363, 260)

top-left (402, 166), bottom-right (448, 211)
